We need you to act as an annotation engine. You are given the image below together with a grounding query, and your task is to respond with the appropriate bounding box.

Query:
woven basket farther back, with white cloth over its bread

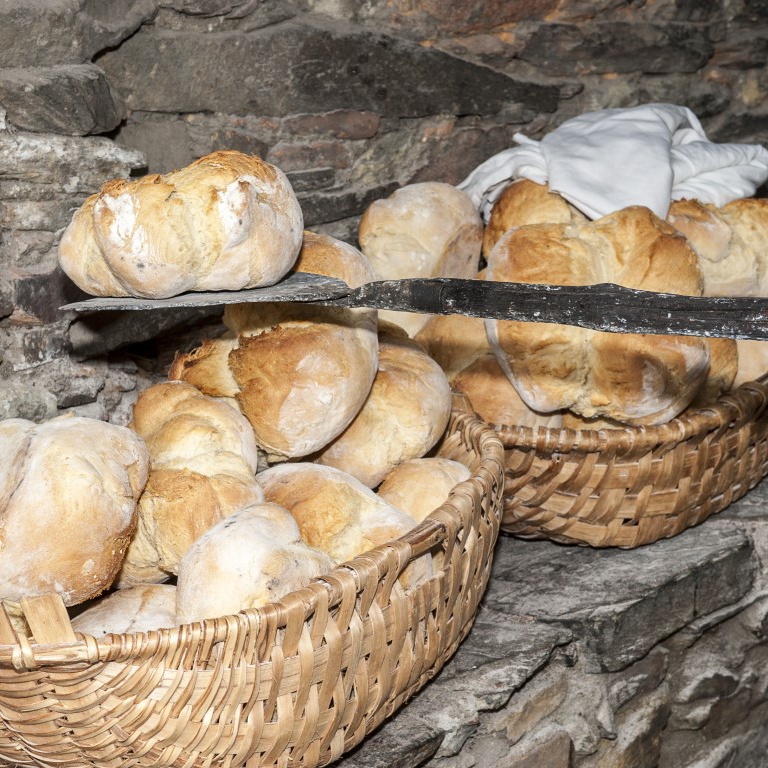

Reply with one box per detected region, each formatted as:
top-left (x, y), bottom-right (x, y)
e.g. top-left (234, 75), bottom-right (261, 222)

top-left (494, 377), bottom-right (768, 549)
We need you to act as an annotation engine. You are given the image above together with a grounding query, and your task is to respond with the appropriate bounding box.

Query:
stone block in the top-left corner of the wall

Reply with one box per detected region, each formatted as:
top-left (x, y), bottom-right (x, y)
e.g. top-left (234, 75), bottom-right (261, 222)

top-left (0, 0), bottom-right (159, 67)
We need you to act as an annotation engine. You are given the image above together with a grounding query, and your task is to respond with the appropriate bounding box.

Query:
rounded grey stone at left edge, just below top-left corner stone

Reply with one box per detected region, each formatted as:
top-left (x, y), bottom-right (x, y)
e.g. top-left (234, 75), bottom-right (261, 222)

top-left (0, 64), bottom-right (124, 136)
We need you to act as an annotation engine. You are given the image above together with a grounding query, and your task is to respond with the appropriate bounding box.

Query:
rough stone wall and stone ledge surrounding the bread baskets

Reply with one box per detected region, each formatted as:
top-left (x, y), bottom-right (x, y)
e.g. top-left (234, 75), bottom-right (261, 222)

top-left (0, 0), bottom-right (768, 768)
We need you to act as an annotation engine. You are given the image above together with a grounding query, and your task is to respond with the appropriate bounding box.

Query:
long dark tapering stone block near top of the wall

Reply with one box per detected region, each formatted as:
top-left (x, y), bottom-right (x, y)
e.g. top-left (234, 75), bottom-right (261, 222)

top-left (99, 16), bottom-right (558, 117)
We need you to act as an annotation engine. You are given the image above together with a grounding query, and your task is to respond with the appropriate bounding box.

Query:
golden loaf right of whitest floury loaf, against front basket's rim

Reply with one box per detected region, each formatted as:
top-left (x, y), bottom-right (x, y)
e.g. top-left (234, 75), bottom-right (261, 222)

top-left (259, 462), bottom-right (426, 562)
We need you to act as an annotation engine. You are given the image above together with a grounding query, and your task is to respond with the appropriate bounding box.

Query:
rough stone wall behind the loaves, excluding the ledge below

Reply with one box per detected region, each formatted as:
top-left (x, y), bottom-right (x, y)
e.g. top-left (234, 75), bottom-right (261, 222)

top-left (0, 0), bottom-right (768, 422)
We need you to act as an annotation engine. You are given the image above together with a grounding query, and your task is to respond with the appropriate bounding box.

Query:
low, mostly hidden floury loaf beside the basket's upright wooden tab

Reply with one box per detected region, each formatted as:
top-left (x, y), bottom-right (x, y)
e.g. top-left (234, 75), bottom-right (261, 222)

top-left (72, 584), bottom-right (176, 637)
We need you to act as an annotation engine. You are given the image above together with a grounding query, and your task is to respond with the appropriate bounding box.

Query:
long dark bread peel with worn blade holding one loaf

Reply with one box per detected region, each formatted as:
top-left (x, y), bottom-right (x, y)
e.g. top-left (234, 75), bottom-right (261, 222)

top-left (61, 272), bottom-right (768, 339)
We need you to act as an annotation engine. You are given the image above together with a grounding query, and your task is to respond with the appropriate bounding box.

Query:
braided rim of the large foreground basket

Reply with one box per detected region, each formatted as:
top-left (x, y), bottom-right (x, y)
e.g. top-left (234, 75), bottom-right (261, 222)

top-left (0, 393), bottom-right (504, 671)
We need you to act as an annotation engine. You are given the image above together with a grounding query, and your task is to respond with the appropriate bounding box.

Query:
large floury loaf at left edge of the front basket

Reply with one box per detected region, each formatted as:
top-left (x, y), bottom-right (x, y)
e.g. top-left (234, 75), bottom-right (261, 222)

top-left (0, 416), bottom-right (149, 605)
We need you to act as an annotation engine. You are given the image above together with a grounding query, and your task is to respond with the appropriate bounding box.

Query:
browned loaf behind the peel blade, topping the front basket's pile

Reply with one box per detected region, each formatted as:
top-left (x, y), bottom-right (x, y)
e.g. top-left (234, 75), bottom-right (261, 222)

top-left (169, 232), bottom-right (378, 462)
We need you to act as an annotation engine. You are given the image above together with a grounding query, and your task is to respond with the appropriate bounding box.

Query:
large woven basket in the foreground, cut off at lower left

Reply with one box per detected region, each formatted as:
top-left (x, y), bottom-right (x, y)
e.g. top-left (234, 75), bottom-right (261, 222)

top-left (0, 398), bottom-right (503, 768)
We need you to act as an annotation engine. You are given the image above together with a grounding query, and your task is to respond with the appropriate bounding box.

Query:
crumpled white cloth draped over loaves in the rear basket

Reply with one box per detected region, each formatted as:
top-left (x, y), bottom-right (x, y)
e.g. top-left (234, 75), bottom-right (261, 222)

top-left (458, 104), bottom-right (768, 221)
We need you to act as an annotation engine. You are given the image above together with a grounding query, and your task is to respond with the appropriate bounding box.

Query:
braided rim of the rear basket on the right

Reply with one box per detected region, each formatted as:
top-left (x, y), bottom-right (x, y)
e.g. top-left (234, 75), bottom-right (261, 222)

top-left (490, 374), bottom-right (768, 455)
